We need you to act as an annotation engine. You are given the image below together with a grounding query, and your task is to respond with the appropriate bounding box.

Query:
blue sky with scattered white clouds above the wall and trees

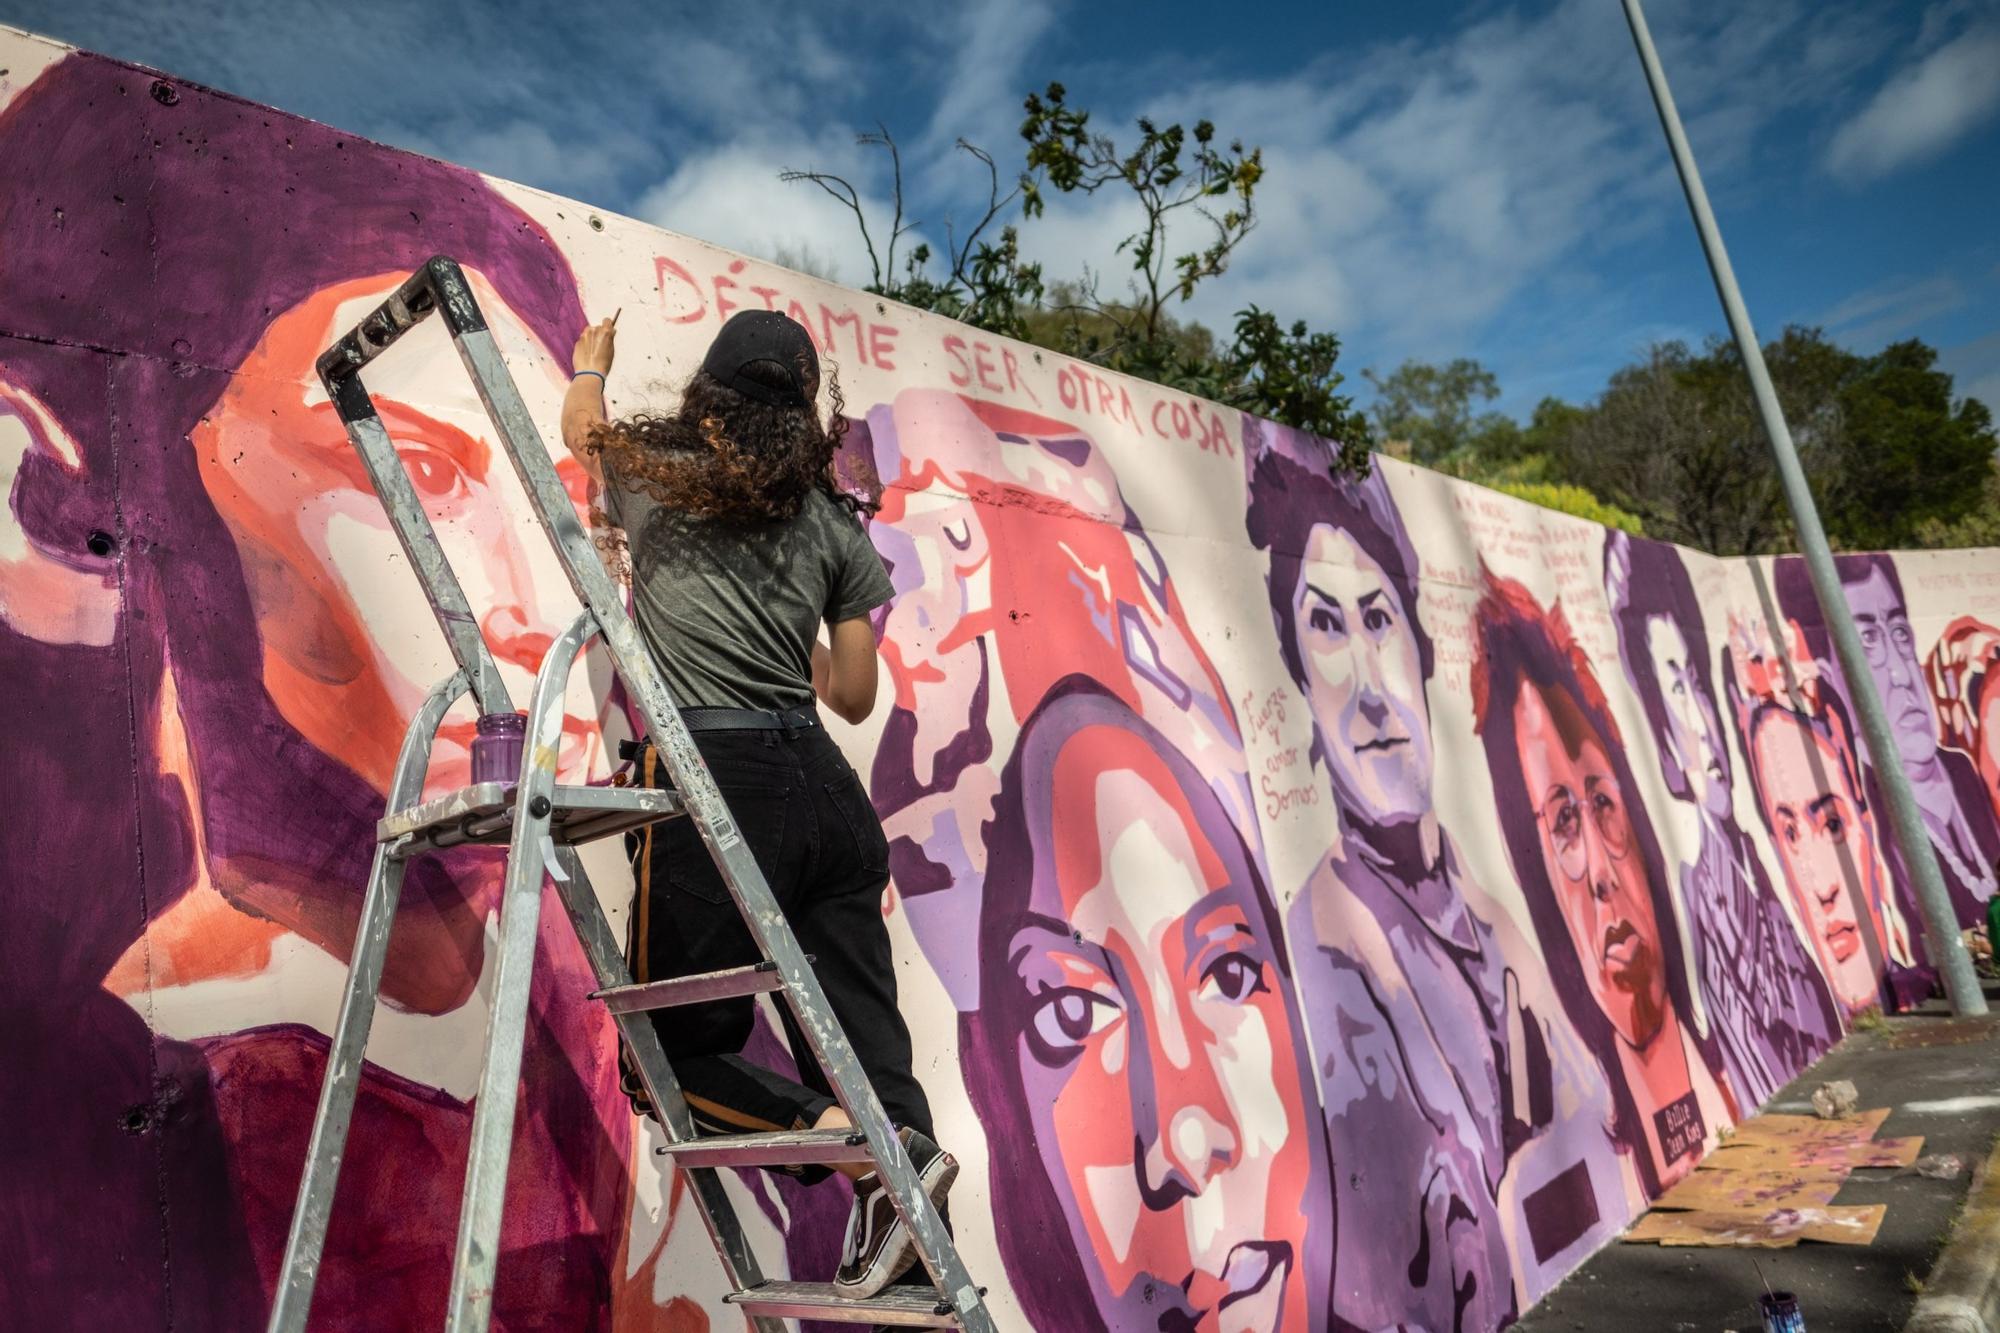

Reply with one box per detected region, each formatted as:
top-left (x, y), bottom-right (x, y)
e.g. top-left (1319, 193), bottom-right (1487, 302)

top-left (0, 0), bottom-right (2000, 412)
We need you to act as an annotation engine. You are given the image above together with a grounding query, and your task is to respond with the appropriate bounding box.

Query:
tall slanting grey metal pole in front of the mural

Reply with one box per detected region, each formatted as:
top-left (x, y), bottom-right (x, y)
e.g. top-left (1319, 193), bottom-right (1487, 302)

top-left (1624, 0), bottom-right (1986, 1015)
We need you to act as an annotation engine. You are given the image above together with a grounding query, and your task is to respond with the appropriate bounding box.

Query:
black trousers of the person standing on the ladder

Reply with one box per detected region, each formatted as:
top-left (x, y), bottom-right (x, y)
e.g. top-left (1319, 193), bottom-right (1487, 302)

top-left (626, 725), bottom-right (936, 1181)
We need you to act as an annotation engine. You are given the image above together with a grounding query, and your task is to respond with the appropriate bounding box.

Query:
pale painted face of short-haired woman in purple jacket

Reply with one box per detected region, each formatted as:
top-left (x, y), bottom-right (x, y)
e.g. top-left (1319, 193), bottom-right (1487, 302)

top-left (1292, 524), bottom-right (1430, 825)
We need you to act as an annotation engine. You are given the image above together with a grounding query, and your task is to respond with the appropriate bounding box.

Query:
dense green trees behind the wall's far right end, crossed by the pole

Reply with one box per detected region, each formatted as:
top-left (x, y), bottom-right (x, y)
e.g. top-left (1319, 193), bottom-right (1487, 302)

top-left (1368, 328), bottom-right (2000, 554)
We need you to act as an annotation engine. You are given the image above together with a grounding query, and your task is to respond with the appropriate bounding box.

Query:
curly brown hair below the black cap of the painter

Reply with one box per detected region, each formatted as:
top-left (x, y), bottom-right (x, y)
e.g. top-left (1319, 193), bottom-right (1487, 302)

top-left (584, 362), bottom-right (876, 526)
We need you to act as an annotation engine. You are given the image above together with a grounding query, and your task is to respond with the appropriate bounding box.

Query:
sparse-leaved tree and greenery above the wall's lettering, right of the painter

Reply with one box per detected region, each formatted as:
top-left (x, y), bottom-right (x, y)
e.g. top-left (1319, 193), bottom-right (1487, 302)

top-left (782, 84), bottom-right (1370, 474)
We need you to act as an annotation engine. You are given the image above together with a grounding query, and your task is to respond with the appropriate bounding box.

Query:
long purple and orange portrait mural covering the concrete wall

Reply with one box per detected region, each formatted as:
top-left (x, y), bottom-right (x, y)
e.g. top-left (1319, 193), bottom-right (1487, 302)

top-left (0, 34), bottom-right (2000, 1333)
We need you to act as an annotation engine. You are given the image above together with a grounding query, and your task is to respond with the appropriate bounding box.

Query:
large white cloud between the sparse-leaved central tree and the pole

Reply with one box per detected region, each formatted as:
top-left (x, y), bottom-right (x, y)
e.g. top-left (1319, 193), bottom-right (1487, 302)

top-left (1064, 2), bottom-right (1664, 364)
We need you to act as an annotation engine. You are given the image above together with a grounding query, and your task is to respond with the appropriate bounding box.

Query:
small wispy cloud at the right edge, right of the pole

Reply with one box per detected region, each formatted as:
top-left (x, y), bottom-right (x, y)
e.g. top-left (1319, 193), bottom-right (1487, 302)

top-left (1826, 24), bottom-right (2000, 184)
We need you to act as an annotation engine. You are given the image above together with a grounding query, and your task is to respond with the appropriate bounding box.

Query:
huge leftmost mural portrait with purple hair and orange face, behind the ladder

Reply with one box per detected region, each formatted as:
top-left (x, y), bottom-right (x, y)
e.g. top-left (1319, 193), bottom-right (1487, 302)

top-left (0, 56), bottom-right (632, 1329)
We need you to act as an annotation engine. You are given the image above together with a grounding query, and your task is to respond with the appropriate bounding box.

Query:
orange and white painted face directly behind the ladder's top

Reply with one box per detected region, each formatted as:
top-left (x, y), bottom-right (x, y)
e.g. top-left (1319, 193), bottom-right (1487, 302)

top-left (192, 270), bottom-right (598, 791)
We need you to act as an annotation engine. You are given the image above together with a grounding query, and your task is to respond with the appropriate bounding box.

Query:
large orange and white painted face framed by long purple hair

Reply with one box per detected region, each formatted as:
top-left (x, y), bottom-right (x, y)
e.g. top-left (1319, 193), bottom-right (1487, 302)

top-left (988, 704), bottom-right (1314, 1333)
